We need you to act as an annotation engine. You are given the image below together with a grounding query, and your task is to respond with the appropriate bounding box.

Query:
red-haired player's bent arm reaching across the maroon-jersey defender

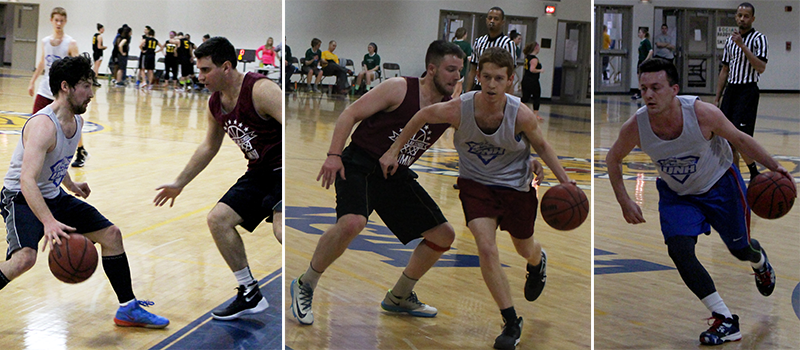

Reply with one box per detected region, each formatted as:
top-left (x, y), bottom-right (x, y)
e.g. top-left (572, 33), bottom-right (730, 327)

top-left (380, 98), bottom-right (461, 178)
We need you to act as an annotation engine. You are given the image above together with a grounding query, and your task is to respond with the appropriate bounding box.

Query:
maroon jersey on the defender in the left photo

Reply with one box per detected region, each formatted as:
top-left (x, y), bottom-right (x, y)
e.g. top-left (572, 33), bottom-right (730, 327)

top-left (208, 72), bottom-right (283, 171)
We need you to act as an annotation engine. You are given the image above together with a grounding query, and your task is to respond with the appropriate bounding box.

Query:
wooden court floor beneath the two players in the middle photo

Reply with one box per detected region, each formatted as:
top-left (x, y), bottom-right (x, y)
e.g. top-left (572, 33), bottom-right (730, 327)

top-left (284, 92), bottom-right (591, 350)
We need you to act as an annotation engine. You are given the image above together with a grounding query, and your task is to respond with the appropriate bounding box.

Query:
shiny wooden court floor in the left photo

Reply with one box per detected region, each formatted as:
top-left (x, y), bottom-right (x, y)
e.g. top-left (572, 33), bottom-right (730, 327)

top-left (0, 70), bottom-right (282, 350)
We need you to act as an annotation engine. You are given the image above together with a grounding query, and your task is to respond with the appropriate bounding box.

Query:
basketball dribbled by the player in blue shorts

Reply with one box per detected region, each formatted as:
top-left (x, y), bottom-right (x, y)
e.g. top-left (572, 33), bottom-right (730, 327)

top-left (747, 171), bottom-right (797, 219)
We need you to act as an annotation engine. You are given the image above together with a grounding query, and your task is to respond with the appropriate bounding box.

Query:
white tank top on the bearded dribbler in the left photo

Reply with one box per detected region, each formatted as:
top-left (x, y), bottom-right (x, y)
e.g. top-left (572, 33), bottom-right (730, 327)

top-left (3, 106), bottom-right (83, 199)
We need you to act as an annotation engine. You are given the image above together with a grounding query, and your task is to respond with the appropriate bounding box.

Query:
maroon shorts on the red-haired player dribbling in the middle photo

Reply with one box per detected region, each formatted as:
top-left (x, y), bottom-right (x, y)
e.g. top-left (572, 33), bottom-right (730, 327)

top-left (458, 177), bottom-right (539, 239)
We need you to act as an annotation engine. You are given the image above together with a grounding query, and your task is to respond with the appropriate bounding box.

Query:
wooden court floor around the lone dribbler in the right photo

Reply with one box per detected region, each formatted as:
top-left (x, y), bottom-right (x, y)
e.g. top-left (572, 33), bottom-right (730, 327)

top-left (593, 94), bottom-right (800, 350)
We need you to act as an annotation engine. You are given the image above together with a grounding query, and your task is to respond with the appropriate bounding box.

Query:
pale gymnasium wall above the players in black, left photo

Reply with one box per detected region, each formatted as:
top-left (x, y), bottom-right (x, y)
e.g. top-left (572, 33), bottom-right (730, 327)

top-left (12, 0), bottom-right (282, 72)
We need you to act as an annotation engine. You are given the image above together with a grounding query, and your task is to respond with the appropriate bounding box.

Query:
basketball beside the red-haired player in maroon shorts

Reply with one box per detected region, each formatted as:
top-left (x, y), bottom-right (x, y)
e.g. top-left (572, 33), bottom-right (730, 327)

top-left (541, 184), bottom-right (589, 231)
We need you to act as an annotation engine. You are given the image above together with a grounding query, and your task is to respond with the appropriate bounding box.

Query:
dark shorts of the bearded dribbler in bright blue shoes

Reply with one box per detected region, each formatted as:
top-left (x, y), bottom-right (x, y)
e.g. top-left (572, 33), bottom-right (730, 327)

top-left (0, 187), bottom-right (113, 260)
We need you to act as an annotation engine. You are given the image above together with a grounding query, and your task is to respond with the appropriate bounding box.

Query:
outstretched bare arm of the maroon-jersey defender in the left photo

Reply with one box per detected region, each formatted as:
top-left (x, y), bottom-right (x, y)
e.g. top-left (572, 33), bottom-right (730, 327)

top-left (153, 110), bottom-right (225, 207)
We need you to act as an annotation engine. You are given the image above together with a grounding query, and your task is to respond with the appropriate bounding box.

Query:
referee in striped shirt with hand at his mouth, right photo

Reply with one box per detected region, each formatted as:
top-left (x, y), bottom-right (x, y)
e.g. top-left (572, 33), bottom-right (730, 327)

top-left (714, 2), bottom-right (768, 179)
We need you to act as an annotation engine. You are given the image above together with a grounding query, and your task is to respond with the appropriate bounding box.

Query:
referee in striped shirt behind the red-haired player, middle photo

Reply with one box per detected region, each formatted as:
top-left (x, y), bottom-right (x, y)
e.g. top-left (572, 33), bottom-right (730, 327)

top-left (466, 6), bottom-right (517, 94)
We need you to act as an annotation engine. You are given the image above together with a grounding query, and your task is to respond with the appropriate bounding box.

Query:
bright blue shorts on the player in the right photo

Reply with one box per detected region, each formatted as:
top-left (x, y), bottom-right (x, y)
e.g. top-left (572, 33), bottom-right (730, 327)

top-left (656, 166), bottom-right (750, 250)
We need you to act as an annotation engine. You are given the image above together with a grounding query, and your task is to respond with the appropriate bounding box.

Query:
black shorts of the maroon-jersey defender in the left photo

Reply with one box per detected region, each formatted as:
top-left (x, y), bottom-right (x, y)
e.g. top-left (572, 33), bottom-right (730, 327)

top-left (219, 169), bottom-right (283, 232)
